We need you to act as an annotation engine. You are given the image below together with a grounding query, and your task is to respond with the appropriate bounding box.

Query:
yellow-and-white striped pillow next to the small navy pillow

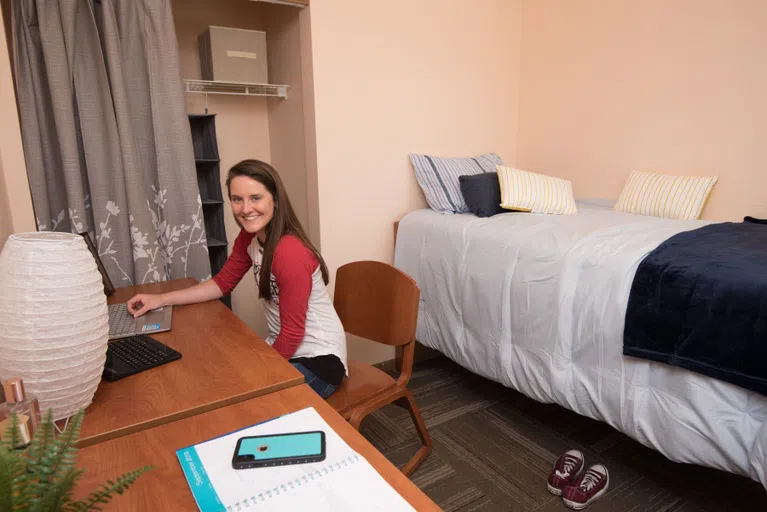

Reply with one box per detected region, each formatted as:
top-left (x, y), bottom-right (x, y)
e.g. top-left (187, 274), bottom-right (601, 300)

top-left (496, 165), bottom-right (578, 215)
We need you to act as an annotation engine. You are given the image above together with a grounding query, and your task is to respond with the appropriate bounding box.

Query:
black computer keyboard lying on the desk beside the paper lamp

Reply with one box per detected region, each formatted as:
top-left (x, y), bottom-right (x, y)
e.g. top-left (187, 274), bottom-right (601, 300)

top-left (103, 334), bottom-right (181, 381)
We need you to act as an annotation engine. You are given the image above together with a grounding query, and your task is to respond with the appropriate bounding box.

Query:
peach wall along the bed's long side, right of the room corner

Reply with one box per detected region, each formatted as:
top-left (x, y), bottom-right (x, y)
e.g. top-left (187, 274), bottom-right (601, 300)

top-left (517, 0), bottom-right (767, 220)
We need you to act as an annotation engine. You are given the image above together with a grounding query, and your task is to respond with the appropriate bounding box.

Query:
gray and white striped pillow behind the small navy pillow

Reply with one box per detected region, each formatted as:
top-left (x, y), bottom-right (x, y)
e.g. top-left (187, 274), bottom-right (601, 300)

top-left (410, 153), bottom-right (503, 213)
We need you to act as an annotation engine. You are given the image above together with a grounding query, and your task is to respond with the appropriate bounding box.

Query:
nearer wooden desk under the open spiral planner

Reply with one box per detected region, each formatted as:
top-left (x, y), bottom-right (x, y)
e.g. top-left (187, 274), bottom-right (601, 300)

top-left (75, 384), bottom-right (440, 512)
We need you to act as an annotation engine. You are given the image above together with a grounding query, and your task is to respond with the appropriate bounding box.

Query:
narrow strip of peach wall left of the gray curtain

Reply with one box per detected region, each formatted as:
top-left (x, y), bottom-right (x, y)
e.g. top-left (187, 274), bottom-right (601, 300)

top-left (0, 3), bottom-right (37, 249)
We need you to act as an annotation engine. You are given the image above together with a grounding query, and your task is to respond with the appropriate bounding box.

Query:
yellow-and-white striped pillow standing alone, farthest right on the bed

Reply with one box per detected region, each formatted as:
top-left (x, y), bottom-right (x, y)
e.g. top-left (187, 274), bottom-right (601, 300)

top-left (613, 169), bottom-right (719, 220)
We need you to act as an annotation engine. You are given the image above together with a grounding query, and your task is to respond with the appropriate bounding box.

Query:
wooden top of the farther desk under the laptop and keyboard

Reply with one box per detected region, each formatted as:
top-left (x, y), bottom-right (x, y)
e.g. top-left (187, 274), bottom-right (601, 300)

top-left (78, 279), bottom-right (304, 447)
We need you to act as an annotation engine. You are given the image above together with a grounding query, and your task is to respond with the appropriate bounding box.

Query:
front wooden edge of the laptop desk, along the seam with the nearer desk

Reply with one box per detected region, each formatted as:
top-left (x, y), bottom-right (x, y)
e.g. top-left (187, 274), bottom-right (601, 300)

top-left (77, 376), bottom-right (304, 448)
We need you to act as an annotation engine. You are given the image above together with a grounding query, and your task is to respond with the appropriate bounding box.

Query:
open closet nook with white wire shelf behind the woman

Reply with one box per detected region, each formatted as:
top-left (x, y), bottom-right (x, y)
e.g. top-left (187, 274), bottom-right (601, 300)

top-left (172, 0), bottom-right (319, 332)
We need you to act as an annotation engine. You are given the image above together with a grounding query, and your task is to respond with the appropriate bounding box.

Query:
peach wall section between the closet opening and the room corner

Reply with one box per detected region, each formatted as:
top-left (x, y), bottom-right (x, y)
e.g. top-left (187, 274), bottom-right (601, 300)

top-left (310, 0), bottom-right (522, 362)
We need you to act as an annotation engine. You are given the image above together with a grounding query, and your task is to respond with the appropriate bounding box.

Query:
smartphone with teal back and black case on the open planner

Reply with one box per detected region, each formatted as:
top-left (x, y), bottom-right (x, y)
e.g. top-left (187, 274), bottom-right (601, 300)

top-left (232, 430), bottom-right (325, 469)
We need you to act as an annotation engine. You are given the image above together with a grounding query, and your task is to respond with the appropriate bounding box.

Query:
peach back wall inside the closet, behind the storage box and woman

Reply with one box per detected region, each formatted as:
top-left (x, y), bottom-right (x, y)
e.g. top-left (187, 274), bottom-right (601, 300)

top-left (172, 0), bottom-right (271, 336)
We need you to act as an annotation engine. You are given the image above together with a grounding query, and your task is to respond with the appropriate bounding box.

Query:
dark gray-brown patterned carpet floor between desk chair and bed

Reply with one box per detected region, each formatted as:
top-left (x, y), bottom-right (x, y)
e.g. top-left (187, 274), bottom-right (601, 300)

top-left (360, 357), bottom-right (767, 512)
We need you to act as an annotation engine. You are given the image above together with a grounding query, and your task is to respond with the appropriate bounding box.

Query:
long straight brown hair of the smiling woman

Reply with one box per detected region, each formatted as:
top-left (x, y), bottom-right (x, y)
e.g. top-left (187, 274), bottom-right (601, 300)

top-left (226, 160), bottom-right (329, 300)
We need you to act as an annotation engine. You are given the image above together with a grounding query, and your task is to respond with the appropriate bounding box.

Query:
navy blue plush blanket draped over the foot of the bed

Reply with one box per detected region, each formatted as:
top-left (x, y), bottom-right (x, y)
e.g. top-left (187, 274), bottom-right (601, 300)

top-left (623, 221), bottom-right (767, 395)
